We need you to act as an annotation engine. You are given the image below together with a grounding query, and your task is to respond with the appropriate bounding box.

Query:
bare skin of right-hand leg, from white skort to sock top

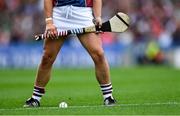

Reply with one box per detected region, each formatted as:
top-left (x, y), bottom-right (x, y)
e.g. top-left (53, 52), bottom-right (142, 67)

top-left (78, 33), bottom-right (110, 84)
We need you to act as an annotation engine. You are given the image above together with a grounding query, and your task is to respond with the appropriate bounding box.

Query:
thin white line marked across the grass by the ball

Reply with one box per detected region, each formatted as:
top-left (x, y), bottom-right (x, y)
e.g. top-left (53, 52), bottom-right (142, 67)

top-left (0, 102), bottom-right (180, 111)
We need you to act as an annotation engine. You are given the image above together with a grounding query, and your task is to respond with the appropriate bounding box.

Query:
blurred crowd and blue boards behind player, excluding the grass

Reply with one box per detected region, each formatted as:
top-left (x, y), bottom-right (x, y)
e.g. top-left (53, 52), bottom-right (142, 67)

top-left (0, 0), bottom-right (180, 68)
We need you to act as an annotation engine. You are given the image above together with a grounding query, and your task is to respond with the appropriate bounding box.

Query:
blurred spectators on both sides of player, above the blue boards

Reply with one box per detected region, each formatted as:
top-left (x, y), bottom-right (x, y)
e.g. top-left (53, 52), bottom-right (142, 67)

top-left (0, 0), bottom-right (180, 49)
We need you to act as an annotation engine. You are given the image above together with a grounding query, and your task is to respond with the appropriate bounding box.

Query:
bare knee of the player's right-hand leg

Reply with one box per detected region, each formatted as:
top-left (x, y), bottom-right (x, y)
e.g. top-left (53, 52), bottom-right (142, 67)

top-left (92, 50), bottom-right (105, 64)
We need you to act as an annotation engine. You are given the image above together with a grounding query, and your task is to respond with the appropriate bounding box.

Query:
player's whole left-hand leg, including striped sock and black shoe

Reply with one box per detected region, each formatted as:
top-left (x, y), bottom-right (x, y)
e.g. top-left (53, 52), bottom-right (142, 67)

top-left (24, 38), bottom-right (65, 107)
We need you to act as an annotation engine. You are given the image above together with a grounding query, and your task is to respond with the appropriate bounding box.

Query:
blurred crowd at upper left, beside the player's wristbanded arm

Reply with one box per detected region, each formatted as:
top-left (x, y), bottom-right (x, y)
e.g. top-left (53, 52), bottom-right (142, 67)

top-left (0, 0), bottom-right (44, 45)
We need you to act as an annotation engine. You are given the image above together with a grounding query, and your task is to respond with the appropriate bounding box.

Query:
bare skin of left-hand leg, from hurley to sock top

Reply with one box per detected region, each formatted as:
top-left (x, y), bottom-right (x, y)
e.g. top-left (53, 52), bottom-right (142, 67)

top-left (35, 37), bottom-right (65, 87)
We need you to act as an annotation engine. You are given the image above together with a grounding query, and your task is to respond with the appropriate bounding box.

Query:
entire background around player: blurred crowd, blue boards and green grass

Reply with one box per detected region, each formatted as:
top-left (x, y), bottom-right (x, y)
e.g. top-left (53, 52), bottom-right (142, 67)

top-left (0, 0), bottom-right (180, 115)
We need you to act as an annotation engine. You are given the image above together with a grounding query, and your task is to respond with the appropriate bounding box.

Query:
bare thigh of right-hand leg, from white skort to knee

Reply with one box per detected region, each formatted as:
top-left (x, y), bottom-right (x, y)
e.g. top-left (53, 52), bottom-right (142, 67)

top-left (78, 33), bottom-right (104, 56)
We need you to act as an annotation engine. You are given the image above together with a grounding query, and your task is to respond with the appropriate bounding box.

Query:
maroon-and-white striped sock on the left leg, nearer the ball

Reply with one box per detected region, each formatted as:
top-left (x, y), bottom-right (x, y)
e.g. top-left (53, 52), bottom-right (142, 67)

top-left (32, 86), bottom-right (45, 102)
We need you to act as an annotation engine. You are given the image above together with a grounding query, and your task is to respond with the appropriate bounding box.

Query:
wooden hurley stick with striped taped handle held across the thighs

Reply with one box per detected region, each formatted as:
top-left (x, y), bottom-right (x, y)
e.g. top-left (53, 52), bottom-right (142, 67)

top-left (35, 12), bottom-right (130, 41)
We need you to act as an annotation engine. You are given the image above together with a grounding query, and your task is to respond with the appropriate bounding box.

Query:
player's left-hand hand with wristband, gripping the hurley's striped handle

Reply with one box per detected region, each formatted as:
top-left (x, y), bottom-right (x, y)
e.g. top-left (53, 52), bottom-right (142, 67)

top-left (44, 22), bottom-right (58, 39)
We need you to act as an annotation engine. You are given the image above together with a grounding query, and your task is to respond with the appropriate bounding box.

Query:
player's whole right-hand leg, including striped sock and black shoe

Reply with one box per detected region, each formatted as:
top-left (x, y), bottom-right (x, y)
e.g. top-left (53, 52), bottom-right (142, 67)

top-left (78, 33), bottom-right (116, 106)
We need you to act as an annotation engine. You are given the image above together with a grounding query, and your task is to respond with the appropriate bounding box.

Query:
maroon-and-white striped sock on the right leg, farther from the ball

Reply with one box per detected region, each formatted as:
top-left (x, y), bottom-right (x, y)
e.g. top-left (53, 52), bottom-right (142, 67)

top-left (100, 83), bottom-right (113, 99)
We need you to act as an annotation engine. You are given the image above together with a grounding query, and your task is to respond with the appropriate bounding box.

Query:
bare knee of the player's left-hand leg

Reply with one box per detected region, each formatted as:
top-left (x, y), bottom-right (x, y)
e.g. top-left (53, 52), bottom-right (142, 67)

top-left (41, 53), bottom-right (55, 69)
